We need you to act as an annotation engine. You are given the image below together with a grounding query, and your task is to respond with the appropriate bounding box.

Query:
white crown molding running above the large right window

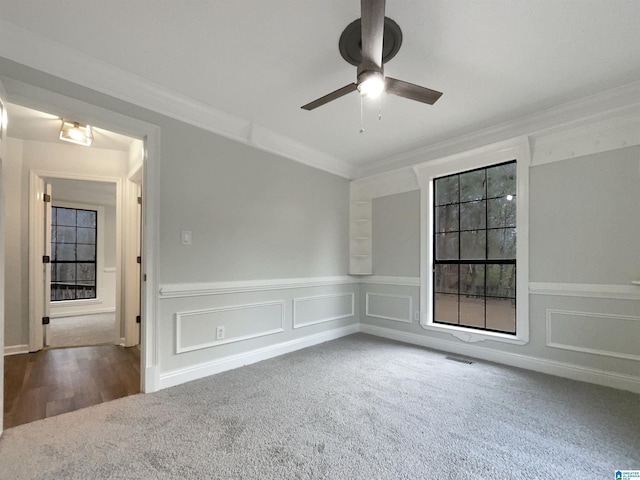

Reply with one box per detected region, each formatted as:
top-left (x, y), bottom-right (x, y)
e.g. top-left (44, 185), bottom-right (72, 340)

top-left (358, 81), bottom-right (640, 178)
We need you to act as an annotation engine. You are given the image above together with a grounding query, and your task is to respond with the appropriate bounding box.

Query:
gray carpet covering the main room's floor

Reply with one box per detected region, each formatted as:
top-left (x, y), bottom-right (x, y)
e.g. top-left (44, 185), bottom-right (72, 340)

top-left (0, 334), bottom-right (640, 480)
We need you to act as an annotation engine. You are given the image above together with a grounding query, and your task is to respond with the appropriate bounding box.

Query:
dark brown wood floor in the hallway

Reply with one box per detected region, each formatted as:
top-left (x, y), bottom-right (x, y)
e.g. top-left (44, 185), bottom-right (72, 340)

top-left (4, 345), bottom-right (140, 429)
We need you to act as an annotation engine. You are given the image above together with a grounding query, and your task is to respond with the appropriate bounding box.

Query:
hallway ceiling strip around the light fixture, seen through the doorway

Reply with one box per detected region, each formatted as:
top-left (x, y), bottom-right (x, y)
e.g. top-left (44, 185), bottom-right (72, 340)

top-left (6, 103), bottom-right (139, 152)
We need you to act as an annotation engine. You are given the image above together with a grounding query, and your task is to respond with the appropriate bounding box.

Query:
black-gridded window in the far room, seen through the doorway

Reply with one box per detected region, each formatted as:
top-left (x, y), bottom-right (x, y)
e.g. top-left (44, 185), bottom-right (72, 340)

top-left (51, 207), bottom-right (98, 301)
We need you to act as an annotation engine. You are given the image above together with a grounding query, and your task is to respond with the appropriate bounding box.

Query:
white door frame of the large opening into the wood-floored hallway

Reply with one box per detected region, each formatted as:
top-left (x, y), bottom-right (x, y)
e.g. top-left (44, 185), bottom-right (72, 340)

top-left (0, 77), bottom-right (160, 393)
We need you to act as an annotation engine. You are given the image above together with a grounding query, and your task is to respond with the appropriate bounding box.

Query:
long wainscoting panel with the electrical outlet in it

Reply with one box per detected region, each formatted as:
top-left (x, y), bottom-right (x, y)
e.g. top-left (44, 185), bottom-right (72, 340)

top-left (176, 300), bottom-right (285, 354)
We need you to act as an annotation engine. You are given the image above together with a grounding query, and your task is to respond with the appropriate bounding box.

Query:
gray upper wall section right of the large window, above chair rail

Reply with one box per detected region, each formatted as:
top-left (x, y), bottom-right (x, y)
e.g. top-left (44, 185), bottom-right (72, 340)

top-left (529, 147), bottom-right (640, 285)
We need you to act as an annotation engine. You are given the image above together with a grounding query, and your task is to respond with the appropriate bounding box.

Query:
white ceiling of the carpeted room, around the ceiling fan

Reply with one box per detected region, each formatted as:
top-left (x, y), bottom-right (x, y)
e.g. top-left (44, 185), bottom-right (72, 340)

top-left (0, 0), bottom-right (640, 176)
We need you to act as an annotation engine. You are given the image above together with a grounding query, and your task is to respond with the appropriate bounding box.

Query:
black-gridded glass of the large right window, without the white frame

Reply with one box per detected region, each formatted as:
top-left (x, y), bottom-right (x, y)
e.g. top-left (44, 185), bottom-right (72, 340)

top-left (432, 161), bottom-right (517, 335)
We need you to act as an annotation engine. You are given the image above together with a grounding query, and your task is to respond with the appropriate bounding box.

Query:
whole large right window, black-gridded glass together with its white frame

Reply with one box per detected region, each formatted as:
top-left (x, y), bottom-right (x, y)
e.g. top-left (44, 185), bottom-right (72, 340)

top-left (413, 137), bottom-right (531, 345)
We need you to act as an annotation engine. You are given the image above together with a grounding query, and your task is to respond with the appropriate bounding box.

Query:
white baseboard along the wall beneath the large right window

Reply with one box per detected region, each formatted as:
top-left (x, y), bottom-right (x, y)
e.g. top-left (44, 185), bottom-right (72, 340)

top-left (360, 323), bottom-right (640, 393)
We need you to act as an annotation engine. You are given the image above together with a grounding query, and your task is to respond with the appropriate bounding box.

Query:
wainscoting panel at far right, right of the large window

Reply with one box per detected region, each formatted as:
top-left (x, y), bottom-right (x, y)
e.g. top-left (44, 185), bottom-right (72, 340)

top-left (546, 309), bottom-right (640, 361)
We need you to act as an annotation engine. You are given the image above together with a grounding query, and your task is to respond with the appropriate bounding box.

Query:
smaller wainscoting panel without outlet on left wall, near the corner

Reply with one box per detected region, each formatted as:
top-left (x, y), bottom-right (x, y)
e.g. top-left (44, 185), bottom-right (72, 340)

top-left (293, 292), bottom-right (355, 328)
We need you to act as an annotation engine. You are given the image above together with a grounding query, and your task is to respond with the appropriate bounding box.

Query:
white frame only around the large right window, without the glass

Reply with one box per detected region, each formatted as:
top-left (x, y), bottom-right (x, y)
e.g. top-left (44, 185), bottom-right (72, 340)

top-left (413, 137), bottom-right (531, 345)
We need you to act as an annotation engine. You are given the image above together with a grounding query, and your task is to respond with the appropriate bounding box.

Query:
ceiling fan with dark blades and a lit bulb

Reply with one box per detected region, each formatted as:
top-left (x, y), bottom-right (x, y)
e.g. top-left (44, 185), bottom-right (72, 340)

top-left (301, 0), bottom-right (442, 110)
